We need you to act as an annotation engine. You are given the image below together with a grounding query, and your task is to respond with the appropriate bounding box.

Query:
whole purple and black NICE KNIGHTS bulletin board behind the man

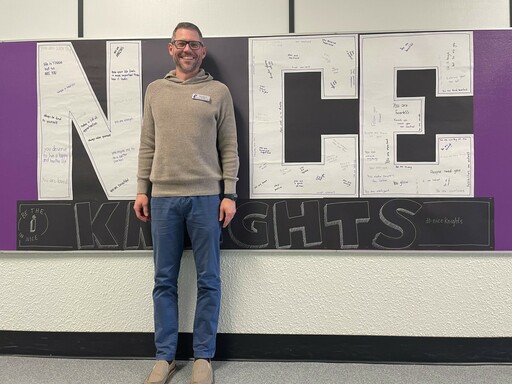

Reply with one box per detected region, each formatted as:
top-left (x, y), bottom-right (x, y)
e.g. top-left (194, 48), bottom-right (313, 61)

top-left (0, 30), bottom-right (512, 251)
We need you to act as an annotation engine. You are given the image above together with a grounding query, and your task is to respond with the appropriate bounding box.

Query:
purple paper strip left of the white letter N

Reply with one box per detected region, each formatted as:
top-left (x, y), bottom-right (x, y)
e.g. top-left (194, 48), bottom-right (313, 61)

top-left (0, 42), bottom-right (37, 250)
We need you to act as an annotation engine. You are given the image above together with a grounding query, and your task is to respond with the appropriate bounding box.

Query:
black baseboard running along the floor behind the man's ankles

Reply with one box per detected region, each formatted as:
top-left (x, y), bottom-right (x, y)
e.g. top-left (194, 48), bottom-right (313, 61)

top-left (0, 331), bottom-right (512, 364)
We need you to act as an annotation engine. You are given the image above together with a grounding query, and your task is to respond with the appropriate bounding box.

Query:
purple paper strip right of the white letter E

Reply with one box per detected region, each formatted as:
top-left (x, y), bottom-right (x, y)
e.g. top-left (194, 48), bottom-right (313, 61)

top-left (473, 30), bottom-right (512, 251)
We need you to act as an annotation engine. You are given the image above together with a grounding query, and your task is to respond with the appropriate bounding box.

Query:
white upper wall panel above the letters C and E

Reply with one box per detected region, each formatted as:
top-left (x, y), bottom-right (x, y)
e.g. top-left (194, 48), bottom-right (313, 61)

top-left (295, 0), bottom-right (510, 33)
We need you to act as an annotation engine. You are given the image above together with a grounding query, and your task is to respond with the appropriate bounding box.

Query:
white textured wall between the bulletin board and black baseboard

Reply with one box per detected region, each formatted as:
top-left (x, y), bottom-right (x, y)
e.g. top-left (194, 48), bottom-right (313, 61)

top-left (0, 251), bottom-right (512, 337)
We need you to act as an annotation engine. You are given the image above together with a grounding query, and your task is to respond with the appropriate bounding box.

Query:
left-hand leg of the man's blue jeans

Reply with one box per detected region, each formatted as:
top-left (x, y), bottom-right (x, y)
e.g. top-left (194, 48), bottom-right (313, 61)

top-left (151, 197), bottom-right (185, 360)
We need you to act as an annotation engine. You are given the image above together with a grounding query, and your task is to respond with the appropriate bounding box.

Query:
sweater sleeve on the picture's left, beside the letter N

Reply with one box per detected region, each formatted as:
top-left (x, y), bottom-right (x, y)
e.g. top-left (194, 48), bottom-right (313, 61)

top-left (137, 85), bottom-right (155, 194)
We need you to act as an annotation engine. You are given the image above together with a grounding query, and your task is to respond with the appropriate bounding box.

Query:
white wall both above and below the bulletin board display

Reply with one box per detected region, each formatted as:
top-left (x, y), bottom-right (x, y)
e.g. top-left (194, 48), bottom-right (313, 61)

top-left (0, 0), bottom-right (512, 337)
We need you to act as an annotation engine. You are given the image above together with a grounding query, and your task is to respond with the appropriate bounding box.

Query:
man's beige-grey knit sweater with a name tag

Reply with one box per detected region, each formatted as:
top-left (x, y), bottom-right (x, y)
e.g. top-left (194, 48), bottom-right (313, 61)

top-left (137, 69), bottom-right (239, 197)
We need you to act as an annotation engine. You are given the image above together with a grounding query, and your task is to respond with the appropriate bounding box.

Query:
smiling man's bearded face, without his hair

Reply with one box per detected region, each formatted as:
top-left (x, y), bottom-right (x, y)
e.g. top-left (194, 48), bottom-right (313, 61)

top-left (169, 29), bottom-right (206, 80)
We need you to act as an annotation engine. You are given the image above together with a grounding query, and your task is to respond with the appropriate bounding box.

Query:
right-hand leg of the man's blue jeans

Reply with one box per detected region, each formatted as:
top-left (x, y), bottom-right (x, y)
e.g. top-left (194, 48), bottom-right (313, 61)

top-left (187, 195), bottom-right (221, 358)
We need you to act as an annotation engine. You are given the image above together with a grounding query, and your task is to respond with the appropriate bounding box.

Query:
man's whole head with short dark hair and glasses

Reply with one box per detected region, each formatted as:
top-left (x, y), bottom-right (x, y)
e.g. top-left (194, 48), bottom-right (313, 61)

top-left (169, 22), bottom-right (206, 80)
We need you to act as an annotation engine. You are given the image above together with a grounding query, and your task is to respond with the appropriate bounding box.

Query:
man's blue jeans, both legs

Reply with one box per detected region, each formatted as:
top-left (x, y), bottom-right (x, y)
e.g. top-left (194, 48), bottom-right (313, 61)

top-left (151, 195), bottom-right (221, 360)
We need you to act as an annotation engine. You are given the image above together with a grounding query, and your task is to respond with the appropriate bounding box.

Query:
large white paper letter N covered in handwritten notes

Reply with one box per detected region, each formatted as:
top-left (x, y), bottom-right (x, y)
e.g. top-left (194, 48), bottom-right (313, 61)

top-left (38, 41), bottom-right (142, 199)
